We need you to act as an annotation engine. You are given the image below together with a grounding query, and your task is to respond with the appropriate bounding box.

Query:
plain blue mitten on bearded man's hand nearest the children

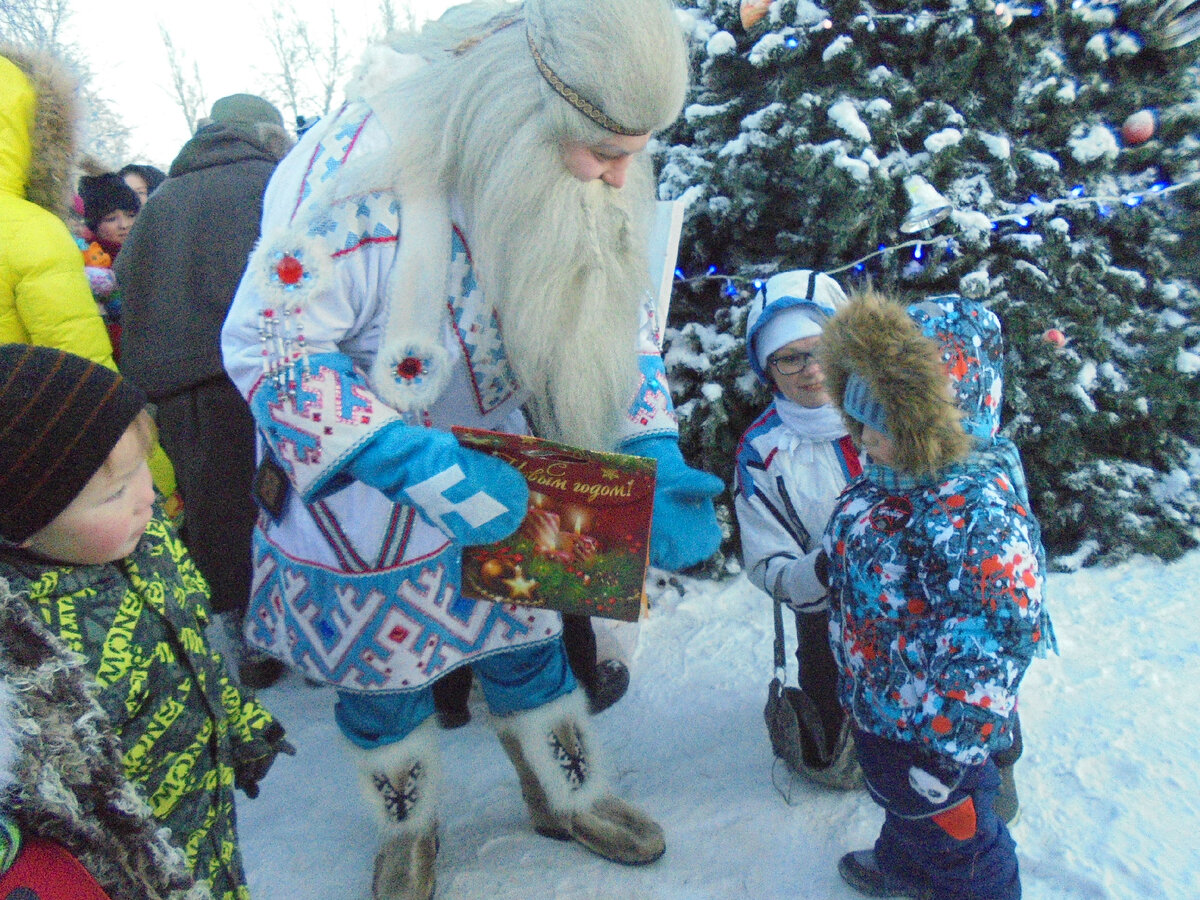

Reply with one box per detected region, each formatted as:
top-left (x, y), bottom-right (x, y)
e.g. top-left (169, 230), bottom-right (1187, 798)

top-left (620, 434), bottom-right (725, 571)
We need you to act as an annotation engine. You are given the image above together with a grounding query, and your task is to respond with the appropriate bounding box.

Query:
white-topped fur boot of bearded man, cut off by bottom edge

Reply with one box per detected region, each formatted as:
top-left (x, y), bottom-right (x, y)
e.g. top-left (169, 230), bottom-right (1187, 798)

top-left (350, 719), bottom-right (442, 900)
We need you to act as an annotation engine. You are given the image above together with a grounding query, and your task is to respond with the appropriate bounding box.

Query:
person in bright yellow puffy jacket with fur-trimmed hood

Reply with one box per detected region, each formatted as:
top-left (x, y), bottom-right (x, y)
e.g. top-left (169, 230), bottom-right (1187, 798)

top-left (0, 44), bottom-right (182, 517)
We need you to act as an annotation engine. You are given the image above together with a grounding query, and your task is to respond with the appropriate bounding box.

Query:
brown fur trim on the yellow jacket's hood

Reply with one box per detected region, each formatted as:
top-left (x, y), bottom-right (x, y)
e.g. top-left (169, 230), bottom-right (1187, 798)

top-left (0, 46), bottom-right (79, 220)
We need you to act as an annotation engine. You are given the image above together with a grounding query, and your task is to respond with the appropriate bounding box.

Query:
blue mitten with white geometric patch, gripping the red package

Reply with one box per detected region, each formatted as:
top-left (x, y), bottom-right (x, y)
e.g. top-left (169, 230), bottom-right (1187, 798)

top-left (346, 422), bottom-right (529, 544)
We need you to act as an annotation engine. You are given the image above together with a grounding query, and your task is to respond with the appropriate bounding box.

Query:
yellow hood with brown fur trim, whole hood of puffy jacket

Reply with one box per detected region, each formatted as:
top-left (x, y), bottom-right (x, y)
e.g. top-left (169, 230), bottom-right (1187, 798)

top-left (0, 44), bottom-right (79, 218)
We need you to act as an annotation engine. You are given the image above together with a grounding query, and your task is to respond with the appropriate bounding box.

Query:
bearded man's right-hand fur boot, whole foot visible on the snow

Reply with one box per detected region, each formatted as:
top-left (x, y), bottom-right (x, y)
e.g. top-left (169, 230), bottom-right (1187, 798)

top-left (497, 690), bottom-right (666, 865)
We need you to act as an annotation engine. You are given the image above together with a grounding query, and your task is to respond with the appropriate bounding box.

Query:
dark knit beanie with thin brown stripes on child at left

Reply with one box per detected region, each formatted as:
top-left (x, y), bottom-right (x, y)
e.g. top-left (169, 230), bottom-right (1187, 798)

top-left (0, 343), bottom-right (146, 544)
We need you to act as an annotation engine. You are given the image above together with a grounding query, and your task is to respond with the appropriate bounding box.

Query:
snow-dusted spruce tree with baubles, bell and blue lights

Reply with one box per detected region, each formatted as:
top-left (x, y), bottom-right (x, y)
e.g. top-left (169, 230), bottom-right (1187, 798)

top-left (660, 0), bottom-right (1200, 564)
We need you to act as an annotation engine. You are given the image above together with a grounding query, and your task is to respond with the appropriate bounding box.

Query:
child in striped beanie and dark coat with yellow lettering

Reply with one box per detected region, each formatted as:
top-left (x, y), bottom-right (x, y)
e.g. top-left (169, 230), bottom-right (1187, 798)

top-left (0, 343), bottom-right (293, 900)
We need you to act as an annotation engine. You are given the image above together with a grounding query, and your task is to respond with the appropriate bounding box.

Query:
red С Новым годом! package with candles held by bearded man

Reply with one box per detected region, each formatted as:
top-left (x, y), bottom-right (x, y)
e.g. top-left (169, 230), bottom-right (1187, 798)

top-left (454, 428), bottom-right (655, 622)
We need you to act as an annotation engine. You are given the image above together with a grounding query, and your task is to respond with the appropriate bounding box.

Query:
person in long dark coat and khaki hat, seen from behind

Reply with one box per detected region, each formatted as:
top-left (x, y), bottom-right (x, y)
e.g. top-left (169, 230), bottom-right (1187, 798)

top-left (116, 94), bottom-right (293, 689)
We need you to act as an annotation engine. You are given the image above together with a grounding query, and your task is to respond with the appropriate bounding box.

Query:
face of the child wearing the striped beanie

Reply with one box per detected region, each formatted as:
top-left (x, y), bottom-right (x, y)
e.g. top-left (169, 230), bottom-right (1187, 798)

top-left (23, 425), bottom-right (154, 565)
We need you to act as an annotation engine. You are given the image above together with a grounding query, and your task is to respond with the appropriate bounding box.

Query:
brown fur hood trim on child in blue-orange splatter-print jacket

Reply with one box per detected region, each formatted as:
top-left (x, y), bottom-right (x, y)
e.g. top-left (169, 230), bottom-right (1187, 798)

top-left (821, 290), bottom-right (972, 475)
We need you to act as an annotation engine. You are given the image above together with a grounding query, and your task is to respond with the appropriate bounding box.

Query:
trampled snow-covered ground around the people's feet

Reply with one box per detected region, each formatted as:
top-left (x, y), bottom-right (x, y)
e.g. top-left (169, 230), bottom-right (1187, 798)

top-left (239, 552), bottom-right (1200, 900)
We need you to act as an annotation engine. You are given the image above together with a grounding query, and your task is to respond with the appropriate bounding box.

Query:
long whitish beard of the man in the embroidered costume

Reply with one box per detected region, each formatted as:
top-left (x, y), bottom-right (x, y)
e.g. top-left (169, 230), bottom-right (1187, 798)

top-left (462, 133), bottom-right (653, 450)
